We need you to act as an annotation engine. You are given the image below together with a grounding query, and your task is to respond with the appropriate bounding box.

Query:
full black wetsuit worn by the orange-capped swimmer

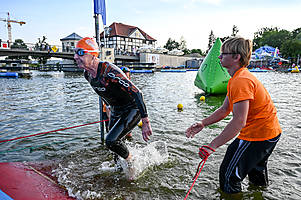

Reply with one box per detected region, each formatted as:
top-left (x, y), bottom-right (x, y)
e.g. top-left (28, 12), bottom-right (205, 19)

top-left (84, 62), bottom-right (147, 158)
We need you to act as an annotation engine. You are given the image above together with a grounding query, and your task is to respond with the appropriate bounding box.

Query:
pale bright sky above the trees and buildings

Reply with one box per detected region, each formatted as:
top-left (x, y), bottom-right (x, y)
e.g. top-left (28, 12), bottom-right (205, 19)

top-left (0, 0), bottom-right (301, 50)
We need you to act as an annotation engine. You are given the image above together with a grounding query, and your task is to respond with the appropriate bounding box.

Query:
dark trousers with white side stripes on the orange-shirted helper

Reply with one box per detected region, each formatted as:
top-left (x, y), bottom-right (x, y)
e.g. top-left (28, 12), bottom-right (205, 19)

top-left (219, 134), bottom-right (281, 193)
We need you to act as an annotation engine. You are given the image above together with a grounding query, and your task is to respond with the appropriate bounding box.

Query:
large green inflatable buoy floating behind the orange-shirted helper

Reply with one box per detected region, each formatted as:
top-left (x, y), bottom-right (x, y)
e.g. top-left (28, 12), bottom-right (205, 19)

top-left (194, 38), bottom-right (230, 94)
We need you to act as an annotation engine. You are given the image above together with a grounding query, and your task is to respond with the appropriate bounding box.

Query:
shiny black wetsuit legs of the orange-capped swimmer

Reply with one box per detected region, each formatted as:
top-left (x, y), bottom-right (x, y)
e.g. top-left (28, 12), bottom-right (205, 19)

top-left (106, 105), bottom-right (141, 159)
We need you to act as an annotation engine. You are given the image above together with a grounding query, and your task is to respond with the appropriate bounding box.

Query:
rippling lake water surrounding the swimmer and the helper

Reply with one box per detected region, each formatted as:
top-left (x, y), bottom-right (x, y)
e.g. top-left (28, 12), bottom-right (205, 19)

top-left (0, 71), bottom-right (301, 200)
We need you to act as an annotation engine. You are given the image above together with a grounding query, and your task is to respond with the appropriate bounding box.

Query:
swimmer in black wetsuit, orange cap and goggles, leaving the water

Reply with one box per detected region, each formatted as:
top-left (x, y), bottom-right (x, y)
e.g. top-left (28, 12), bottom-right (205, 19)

top-left (74, 37), bottom-right (152, 161)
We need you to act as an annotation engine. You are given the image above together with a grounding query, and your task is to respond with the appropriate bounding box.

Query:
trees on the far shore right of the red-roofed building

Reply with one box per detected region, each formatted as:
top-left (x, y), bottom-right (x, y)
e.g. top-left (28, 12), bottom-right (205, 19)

top-left (164, 25), bottom-right (301, 61)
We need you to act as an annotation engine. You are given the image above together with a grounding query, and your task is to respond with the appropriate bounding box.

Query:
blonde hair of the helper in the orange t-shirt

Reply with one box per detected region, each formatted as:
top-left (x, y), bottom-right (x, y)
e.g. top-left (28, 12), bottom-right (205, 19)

top-left (221, 37), bottom-right (253, 67)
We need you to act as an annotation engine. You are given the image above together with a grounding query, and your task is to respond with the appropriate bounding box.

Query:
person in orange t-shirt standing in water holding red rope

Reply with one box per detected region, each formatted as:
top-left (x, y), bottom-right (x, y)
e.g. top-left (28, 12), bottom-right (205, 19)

top-left (186, 37), bottom-right (281, 194)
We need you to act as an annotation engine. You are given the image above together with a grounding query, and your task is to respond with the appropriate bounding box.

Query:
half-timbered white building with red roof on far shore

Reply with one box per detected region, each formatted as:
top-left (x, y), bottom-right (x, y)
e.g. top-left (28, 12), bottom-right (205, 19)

top-left (100, 22), bottom-right (157, 55)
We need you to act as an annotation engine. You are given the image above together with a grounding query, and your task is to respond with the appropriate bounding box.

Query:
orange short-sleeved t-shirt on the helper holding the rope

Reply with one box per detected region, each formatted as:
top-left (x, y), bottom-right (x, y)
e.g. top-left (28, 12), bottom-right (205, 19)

top-left (227, 67), bottom-right (281, 141)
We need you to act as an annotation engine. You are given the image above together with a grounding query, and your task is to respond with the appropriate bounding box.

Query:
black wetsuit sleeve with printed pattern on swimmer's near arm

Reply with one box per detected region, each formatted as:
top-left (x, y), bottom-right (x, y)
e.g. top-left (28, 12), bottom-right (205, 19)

top-left (104, 63), bottom-right (148, 118)
